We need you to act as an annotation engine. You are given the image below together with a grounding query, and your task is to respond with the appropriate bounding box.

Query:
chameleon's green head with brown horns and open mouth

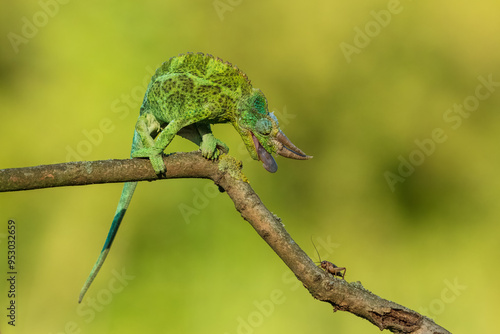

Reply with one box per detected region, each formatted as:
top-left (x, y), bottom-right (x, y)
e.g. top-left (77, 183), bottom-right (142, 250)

top-left (235, 88), bottom-right (312, 173)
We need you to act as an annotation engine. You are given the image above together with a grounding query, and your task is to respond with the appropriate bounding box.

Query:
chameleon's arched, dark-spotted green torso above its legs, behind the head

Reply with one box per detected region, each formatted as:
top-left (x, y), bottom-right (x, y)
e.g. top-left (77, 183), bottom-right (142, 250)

top-left (141, 53), bottom-right (252, 120)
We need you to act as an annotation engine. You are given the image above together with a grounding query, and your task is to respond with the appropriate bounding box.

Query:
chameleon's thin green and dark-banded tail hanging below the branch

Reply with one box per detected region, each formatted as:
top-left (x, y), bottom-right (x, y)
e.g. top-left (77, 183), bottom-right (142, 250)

top-left (78, 182), bottom-right (137, 303)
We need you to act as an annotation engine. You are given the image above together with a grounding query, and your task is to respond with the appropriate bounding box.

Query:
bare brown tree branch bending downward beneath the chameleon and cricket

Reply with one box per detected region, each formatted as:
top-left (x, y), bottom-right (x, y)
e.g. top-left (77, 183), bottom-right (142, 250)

top-left (0, 152), bottom-right (449, 334)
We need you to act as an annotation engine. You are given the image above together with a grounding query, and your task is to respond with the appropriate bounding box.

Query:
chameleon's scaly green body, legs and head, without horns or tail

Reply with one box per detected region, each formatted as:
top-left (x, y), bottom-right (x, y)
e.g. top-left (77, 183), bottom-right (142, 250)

top-left (132, 54), bottom-right (288, 174)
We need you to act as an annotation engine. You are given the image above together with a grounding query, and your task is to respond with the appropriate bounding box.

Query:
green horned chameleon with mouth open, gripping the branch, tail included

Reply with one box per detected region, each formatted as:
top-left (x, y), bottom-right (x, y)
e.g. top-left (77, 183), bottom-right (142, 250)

top-left (79, 53), bottom-right (312, 302)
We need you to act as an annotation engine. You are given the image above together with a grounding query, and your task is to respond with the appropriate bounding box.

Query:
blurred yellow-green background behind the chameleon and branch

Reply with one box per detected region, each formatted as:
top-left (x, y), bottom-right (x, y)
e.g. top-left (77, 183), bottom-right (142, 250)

top-left (0, 0), bottom-right (500, 334)
